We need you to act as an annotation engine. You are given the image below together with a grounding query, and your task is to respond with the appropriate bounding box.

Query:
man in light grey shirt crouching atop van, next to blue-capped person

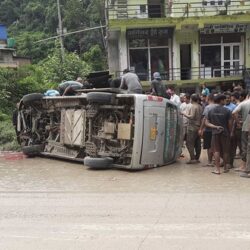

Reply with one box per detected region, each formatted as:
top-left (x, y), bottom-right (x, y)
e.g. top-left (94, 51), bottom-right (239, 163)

top-left (120, 69), bottom-right (142, 94)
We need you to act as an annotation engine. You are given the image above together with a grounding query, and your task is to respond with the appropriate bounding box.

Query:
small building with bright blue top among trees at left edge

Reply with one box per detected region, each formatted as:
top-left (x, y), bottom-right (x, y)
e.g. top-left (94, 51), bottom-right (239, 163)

top-left (0, 24), bottom-right (31, 68)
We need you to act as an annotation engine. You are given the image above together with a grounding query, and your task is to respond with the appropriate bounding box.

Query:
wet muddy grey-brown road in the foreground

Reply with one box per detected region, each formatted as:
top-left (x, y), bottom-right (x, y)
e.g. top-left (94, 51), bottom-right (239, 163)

top-left (0, 152), bottom-right (250, 250)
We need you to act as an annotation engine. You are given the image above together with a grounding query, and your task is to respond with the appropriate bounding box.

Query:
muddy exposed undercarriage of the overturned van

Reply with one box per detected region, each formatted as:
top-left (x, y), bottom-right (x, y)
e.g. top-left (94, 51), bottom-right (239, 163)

top-left (17, 92), bottom-right (135, 168)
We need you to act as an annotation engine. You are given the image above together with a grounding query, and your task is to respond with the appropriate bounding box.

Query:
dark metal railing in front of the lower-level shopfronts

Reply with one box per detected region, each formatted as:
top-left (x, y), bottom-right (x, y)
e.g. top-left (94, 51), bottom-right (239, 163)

top-left (115, 65), bottom-right (245, 81)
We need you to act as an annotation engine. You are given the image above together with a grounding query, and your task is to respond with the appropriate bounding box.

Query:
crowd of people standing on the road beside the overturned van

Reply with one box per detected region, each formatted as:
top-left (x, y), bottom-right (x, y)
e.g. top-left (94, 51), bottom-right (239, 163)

top-left (180, 86), bottom-right (250, 178)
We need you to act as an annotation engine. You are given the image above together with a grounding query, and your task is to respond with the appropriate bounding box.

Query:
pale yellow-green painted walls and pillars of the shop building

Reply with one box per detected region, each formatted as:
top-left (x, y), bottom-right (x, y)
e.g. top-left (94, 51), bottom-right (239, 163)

top-left (109, 0), bottom-right (250, 84)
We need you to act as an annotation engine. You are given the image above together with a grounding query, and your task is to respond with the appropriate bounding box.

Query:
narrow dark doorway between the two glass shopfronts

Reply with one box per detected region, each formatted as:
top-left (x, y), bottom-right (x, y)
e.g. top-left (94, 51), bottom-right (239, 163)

top-left (180, 44), bottom-right (192, 80)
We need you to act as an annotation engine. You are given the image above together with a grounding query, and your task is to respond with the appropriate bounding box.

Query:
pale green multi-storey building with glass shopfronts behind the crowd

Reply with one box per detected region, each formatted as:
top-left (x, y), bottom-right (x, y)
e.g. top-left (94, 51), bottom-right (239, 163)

top-left (106, 0), bottom-right (250, 89)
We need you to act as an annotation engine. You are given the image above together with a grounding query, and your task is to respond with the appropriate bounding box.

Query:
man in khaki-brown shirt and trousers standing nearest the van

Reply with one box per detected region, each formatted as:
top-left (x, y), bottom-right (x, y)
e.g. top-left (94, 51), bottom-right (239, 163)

top-left (182, 94), bottom-right (202, 164)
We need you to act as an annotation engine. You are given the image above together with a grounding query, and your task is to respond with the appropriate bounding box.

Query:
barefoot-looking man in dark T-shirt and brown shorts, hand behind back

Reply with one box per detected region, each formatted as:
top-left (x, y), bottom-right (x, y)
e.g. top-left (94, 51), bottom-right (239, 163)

top-left (205, 94), bottom-right (232, 174)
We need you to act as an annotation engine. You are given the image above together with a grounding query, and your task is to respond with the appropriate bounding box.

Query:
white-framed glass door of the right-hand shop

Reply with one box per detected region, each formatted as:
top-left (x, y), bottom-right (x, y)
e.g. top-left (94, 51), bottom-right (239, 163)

top-left (222, 44), bottom-right (240, 76)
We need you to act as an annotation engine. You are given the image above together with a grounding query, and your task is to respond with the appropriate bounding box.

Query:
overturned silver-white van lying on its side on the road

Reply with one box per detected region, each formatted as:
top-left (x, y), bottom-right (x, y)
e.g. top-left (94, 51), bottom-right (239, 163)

top-left (16, 89), bottom-right (182, 170)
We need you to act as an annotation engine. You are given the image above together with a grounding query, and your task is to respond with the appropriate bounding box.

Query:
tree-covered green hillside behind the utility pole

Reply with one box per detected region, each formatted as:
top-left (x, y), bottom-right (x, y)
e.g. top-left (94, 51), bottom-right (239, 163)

top-left (0, 0), bottom-right (105, 63)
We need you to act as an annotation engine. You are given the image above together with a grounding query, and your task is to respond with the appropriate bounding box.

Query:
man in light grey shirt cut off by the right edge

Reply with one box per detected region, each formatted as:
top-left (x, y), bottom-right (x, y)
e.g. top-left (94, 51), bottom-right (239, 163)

top-left (233, 92), bottom-right (250, 172)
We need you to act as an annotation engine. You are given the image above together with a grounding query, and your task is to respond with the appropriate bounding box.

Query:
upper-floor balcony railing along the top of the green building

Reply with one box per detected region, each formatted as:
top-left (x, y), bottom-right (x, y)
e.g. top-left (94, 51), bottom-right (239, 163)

top-left (107, 0), bottom-right (250, 20)
